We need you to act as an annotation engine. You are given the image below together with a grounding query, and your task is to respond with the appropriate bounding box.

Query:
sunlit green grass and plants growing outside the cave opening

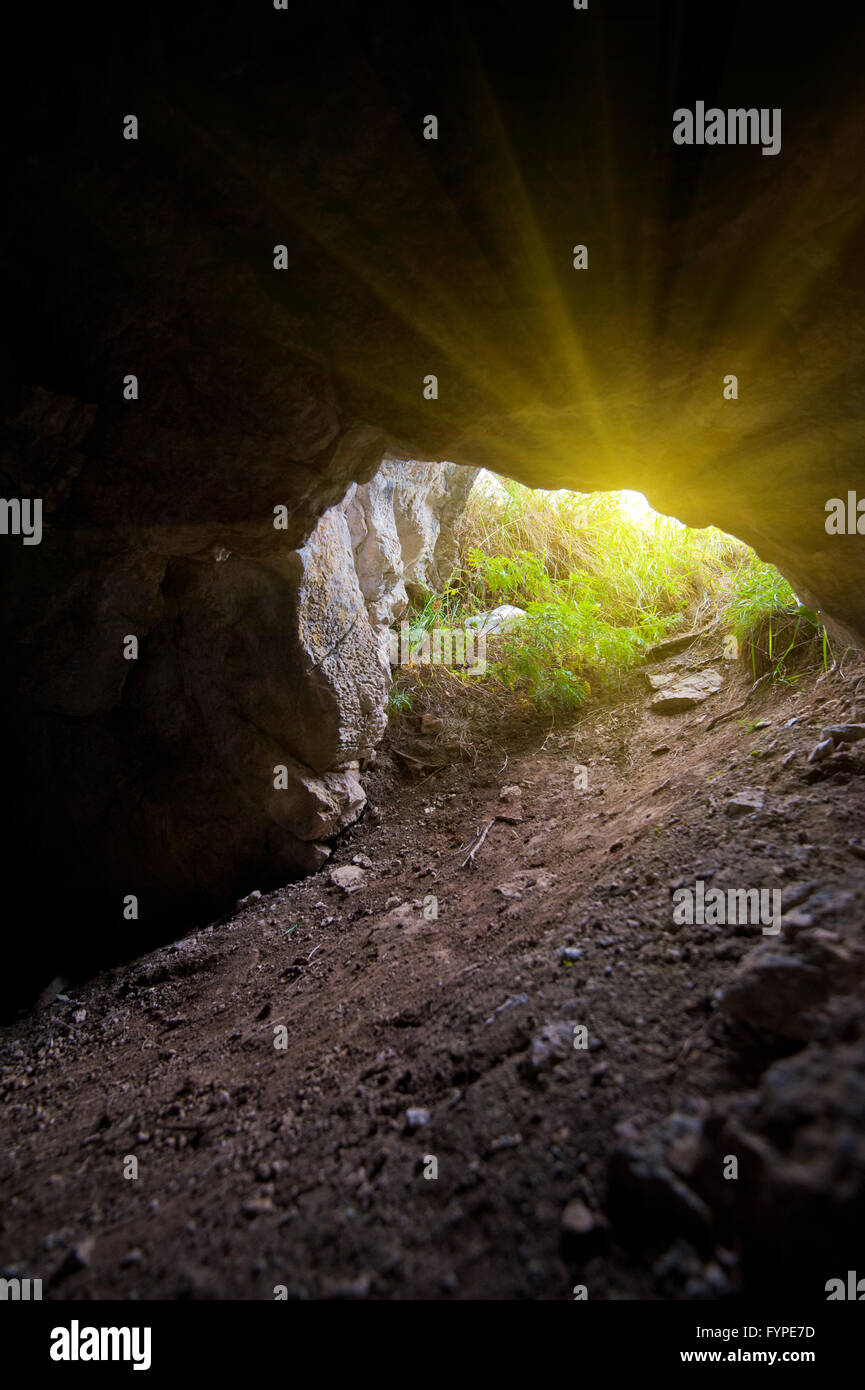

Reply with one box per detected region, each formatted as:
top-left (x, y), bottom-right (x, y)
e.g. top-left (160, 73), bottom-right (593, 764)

top-left (391, 475), bottom-right (829, 712)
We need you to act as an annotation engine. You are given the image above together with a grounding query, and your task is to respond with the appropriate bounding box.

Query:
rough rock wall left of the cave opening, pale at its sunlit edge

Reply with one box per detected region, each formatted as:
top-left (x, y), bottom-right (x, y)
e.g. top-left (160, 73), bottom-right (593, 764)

top-left (6, 459), bottom-right (474, 1006)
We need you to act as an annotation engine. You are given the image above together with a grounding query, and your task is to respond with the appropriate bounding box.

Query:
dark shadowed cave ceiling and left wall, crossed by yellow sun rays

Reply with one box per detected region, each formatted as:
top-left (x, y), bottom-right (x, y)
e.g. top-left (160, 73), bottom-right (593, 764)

top-left (0, 0), bottom-right (865, 1000)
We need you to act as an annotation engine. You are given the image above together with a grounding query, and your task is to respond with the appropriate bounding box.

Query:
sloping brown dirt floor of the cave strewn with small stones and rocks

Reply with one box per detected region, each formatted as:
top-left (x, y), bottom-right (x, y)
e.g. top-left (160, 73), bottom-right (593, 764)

top-left (0, 648), bottom-right (865, 1300)
